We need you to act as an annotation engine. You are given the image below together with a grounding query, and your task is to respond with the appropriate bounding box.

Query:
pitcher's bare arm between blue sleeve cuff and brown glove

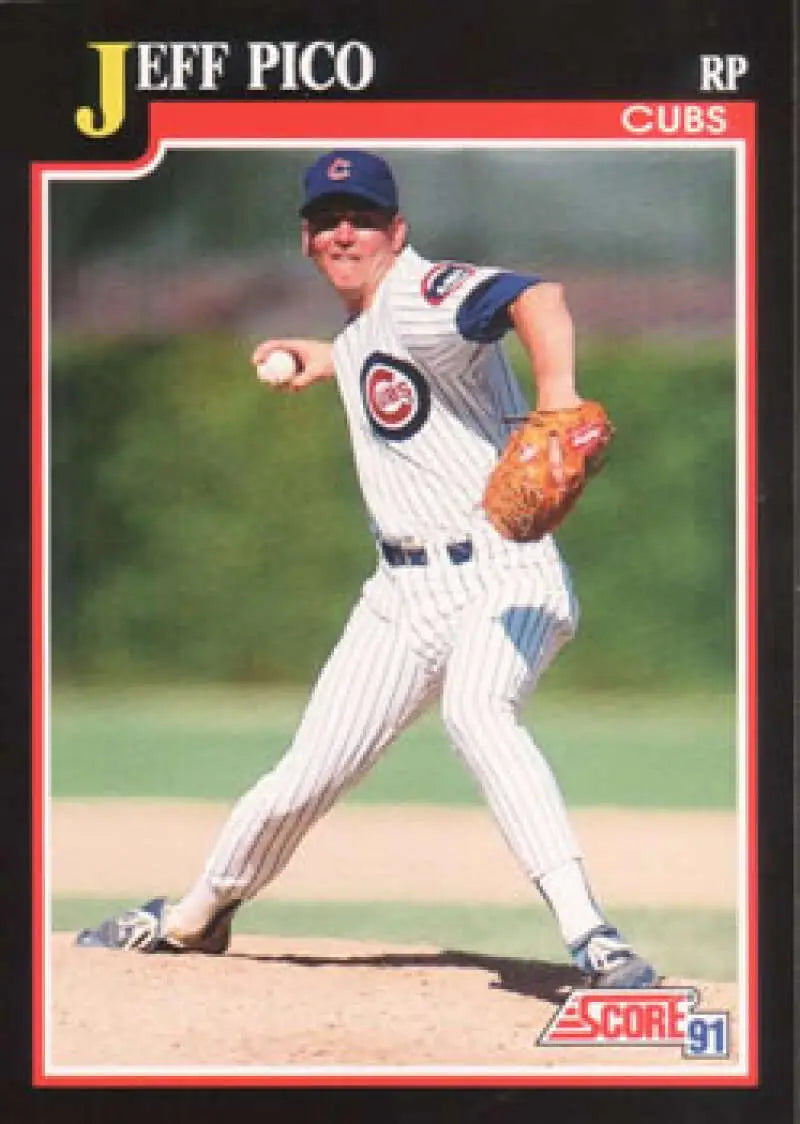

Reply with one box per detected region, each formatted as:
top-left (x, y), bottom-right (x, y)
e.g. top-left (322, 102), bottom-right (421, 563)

top-left (507, 281), bottom-right (582, 410)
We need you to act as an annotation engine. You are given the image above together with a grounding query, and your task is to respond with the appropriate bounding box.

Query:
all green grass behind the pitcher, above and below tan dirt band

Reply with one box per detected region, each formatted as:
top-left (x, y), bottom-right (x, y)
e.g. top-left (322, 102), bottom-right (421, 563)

top-left (51, 688), bottom-right (736, 980)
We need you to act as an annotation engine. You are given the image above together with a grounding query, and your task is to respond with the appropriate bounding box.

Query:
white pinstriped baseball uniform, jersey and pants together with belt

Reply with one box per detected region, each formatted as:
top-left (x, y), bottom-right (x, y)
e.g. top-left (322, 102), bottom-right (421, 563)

top-left (206, 247), bottom-right (580, 903)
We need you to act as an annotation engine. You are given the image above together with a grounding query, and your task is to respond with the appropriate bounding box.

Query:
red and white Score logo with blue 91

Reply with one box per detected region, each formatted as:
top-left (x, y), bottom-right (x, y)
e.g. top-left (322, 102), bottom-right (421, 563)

top-left (538, 987), bottom-right (729, 1058)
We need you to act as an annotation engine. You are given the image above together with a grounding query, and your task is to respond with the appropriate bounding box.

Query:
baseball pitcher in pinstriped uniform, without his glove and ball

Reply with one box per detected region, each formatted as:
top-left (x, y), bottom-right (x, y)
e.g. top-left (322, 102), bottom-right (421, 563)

top-left (78, 149), bottom-right (658, 988)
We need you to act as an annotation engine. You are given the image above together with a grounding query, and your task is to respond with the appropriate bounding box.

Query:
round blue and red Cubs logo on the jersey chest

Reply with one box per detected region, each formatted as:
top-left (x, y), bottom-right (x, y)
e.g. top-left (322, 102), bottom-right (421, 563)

top-left (361, 352), bottom-right (430, 441)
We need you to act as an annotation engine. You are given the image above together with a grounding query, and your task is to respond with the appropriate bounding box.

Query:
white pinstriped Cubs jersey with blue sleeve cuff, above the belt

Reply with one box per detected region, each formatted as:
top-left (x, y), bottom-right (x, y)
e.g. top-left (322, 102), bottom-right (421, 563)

top-left (333, 246), bottom-right (539, 541)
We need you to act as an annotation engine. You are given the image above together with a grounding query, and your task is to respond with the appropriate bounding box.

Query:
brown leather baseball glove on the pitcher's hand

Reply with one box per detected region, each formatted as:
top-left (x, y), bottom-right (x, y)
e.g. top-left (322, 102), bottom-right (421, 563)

top-left (483, 401), bottom-right (615, 543)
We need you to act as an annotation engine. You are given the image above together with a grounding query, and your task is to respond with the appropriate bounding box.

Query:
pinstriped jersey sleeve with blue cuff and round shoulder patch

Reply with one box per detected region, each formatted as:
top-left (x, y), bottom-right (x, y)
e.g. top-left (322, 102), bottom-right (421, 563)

top-left (392, 262), bottom-right (540, 364)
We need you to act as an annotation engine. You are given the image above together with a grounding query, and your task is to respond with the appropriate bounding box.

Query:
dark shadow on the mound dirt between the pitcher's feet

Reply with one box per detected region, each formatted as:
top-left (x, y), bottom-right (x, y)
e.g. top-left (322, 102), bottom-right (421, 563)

top-left (228, 949), bottom-right (583, 1004)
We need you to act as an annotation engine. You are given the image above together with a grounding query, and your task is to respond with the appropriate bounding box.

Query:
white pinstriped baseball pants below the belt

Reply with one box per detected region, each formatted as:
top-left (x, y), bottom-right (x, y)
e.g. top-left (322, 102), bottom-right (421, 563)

top-left (206, 540), bottom-right (581, 903)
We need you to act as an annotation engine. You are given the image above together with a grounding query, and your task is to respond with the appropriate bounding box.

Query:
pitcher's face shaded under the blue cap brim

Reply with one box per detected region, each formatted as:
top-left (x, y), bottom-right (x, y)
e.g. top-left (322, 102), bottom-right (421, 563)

top-left (302, 200), bottom-right (407, 311)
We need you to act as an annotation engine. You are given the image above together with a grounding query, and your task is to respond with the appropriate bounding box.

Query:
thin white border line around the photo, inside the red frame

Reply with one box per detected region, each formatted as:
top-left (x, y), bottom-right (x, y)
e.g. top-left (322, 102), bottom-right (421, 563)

top-left (40, 137), bottom-right (755, 1088)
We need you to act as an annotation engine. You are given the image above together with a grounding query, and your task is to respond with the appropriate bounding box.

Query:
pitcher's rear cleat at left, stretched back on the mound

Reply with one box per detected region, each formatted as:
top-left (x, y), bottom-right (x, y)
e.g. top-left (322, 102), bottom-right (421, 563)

top-left (75, 898), bottom-right (239, 955)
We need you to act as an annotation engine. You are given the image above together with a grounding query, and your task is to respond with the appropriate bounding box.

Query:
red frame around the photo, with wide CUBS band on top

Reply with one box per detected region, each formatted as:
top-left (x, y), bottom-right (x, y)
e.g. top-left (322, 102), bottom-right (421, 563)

top-left (30, 100), bottom-right (758, 1087)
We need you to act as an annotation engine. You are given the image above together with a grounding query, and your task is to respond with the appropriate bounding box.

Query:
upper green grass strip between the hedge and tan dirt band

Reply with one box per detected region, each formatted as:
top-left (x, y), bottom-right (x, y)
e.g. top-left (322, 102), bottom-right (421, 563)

top-left (51, 687), bottom-right (736, 808)
